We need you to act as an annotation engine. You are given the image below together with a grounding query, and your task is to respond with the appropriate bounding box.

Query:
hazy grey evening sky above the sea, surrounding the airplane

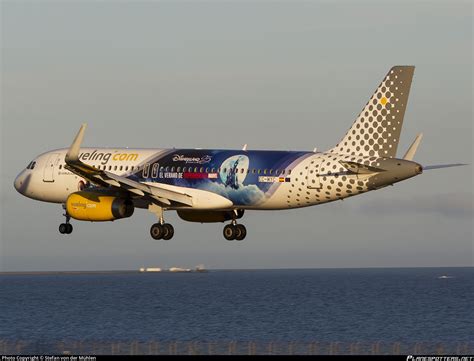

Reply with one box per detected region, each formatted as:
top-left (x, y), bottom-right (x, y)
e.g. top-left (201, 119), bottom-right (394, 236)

top-left (0, 1), bottom-right (474, 272)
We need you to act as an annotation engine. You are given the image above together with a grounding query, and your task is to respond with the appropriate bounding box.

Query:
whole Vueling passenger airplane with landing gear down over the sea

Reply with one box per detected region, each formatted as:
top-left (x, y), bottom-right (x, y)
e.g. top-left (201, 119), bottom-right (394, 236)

top-left (14, 66), bottom-right (464, 241)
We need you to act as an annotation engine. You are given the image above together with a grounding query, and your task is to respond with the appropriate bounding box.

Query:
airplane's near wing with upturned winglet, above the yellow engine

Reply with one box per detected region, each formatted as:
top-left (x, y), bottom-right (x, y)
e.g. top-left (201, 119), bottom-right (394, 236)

top-left (65, 124), bottom-right (193, 206)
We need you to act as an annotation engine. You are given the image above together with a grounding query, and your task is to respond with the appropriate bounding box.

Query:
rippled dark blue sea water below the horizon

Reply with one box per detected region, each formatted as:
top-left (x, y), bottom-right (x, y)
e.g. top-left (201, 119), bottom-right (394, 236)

top-left (0, 268), bottom-right (474, 342)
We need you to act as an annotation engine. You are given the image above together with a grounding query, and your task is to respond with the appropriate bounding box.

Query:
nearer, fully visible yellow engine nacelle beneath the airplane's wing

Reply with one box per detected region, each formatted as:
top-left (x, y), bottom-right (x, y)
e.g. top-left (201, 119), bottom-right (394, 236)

top-left (66, 192), bottom-right (135, 222)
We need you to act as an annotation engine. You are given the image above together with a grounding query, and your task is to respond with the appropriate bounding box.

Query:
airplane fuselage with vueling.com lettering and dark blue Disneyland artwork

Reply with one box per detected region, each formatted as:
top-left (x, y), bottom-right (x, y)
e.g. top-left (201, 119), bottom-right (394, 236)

top-left (15, 148), bottom-right (421, 210)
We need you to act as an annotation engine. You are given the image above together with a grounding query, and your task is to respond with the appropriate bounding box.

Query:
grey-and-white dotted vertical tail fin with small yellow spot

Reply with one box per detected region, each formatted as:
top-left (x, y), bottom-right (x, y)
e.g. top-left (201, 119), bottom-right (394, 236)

top-left (330, 66), bottom-right (415, 158)
